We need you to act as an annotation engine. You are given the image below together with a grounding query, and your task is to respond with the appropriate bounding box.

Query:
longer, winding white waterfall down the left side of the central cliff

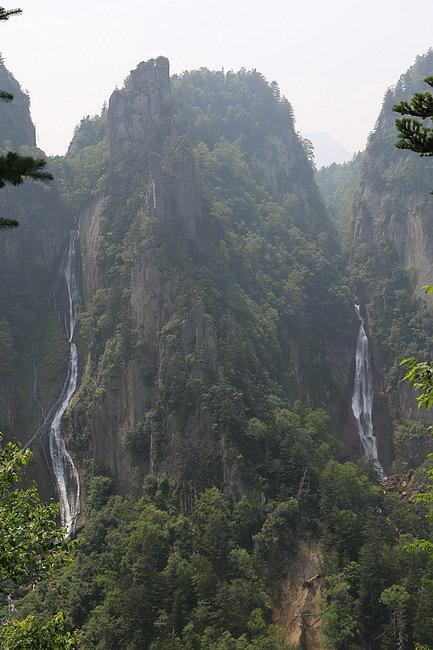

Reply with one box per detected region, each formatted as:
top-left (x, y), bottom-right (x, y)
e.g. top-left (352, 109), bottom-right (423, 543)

top-left (49, 231), bottom-right (80, 535)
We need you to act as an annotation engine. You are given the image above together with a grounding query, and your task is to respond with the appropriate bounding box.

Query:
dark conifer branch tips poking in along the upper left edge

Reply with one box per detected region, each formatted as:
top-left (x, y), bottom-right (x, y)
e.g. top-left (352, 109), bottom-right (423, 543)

top-left (0, 7), bottom-right (53, 230)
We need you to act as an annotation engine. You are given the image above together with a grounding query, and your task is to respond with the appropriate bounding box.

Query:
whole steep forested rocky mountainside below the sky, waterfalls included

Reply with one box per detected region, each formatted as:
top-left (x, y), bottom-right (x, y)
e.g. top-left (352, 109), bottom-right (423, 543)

top-left (0, 55), bottom-right (433, 650)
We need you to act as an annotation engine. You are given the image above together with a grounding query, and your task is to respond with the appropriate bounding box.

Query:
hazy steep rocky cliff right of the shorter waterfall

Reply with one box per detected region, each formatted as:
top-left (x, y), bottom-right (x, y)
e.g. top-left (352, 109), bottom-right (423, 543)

top-left (352, 52), bottom-right (433, 436)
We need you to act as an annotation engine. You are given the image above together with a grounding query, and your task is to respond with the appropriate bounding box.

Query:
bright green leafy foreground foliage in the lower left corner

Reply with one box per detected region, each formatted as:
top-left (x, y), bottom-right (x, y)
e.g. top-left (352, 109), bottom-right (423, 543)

top-left (0, 442), bottom-right (78, 650)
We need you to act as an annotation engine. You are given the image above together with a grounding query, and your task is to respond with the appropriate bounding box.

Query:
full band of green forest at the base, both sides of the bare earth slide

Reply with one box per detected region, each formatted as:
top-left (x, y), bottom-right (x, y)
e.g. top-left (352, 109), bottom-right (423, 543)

top-left (18, 450), bottom-right (433, 650)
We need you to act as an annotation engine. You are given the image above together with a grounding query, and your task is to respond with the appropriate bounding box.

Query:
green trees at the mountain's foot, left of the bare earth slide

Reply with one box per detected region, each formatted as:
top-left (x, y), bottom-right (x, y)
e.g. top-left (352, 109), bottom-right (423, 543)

top-left (20, 486), bottom-right (284, 650)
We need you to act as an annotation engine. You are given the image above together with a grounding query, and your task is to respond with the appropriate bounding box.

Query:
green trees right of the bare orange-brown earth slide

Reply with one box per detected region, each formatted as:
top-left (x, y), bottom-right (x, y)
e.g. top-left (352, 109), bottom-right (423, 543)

top-left (321, 478), bottom-right (433, 650)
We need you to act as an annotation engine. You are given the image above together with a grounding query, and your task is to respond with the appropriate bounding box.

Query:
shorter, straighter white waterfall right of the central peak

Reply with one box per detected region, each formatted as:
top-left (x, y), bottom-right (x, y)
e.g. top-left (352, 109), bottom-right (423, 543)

top-left (352, 305), bottom-right (384, 477)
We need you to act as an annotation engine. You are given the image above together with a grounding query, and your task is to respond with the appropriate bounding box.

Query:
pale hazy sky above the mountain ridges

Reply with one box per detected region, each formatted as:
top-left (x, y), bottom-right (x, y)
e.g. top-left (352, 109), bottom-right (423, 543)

top-left (0, 0), bottom-right (433, 154)
